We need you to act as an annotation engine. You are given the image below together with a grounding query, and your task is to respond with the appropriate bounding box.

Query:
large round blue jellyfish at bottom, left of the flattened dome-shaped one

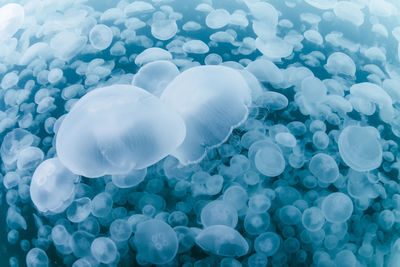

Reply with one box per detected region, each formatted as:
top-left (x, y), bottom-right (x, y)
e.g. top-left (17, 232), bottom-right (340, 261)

top-left (134, 219), bottom-right (179, 264)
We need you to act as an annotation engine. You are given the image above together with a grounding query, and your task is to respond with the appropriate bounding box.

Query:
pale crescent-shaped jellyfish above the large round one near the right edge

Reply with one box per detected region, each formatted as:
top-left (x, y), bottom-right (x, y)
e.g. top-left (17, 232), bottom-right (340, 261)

top-left (350, 82), bottom-right (394, 122)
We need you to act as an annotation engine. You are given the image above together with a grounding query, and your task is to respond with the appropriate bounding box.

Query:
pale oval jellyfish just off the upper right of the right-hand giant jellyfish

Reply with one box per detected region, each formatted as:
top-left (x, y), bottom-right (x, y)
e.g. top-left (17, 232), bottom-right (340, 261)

top-left (246, 59), bottom-right (283, 84)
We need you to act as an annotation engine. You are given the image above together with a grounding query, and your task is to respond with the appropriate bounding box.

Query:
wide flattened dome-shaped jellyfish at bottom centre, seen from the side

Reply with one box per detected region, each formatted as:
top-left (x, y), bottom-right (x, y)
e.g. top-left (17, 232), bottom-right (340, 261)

top-left (196, 225), bottom-right (249, 257)
